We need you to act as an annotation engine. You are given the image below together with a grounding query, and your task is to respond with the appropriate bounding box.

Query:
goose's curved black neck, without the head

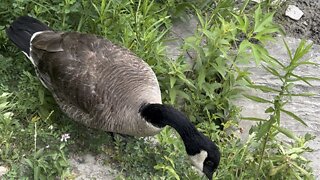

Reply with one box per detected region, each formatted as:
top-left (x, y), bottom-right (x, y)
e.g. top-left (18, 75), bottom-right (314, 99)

top-left (140, 104), bottom-right (203, 155)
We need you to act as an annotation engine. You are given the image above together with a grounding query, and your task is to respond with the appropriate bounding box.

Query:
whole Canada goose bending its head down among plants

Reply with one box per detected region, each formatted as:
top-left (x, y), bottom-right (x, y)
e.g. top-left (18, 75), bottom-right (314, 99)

top-left (6, 16), bottom-right (220, 179)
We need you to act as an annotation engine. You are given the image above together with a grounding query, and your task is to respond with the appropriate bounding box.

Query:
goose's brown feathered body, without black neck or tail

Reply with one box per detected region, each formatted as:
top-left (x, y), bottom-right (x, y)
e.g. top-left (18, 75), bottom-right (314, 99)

top-left (30, 31), bottom-right (161, 136)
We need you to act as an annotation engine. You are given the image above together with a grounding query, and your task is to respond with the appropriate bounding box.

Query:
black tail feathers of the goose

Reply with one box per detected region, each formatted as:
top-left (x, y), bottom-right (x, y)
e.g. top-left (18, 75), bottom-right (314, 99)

top-left (6, 16), bottom-right (50, 57)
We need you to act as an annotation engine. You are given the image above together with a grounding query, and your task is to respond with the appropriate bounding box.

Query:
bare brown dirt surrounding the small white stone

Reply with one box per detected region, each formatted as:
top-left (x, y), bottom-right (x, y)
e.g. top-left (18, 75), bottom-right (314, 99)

top-left (276, 0), bottom-right (320, 44)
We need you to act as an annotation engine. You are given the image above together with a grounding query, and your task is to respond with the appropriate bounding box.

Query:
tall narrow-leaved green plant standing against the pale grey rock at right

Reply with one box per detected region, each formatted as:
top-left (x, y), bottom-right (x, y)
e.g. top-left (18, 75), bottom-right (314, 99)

top-left (244, 40), bottom-right (320, 179)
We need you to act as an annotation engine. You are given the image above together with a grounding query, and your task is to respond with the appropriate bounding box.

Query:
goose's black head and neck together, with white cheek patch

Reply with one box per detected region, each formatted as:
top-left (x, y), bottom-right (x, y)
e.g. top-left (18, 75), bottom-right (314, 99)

top-left (140, 104), bottom-right (220, 180)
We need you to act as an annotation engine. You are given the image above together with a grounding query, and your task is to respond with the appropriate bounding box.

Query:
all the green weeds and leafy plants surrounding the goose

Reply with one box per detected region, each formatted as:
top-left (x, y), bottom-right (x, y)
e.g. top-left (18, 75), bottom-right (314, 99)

top-left (0, 0), bottom-right (317, 179)
